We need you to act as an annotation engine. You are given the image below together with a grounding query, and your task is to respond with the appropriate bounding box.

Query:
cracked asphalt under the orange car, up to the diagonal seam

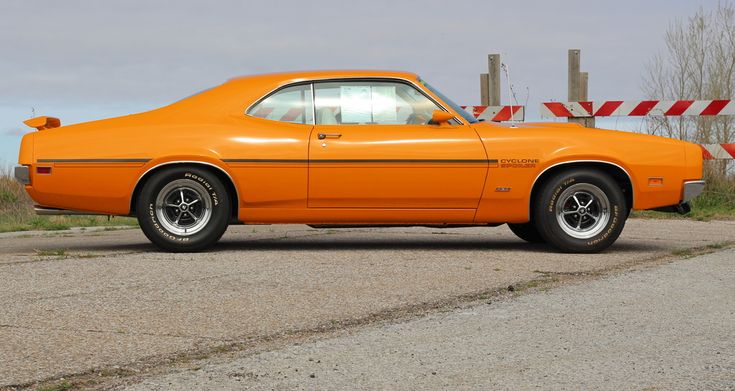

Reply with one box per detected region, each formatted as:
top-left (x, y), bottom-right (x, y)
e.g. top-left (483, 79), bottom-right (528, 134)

top-left (0, 220), bottom-right (735, 387)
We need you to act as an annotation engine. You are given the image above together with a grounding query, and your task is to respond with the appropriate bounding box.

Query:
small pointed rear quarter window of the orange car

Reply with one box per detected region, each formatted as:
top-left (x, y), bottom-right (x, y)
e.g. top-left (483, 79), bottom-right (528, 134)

top-left (247, 84), bottom-right (314, 125)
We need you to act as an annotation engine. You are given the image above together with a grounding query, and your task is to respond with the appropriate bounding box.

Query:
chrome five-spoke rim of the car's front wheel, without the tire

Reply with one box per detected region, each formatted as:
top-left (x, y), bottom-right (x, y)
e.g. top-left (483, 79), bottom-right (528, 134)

top-left (556, 183), bottom-right (610, 239)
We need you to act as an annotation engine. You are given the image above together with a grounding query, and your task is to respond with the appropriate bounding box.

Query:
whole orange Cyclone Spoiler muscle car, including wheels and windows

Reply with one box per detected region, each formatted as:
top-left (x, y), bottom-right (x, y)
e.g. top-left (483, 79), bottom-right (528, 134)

top-left (15, 71), bottom-right (704, 252)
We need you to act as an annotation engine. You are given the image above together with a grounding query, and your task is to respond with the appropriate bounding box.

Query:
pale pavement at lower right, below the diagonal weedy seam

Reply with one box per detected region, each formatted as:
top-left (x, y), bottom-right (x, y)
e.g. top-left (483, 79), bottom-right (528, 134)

top-left (125, 250), bottom-right (735, 391)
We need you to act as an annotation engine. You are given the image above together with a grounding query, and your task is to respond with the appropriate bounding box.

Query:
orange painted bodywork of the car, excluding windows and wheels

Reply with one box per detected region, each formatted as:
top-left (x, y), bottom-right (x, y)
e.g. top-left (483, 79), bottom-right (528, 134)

top-left (19, 71), bottom-right (702, 224)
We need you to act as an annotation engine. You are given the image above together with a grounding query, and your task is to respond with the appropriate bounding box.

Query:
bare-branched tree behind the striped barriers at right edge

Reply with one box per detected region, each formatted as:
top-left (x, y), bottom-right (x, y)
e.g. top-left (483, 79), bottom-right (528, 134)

top-left (643, 2), bottom-right (735, 176)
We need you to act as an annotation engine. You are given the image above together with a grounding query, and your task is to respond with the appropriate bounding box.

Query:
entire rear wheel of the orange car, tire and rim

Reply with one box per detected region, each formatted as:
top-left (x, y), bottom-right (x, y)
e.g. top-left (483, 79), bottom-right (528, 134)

top-left (136, 167), bottom-right (232, 252)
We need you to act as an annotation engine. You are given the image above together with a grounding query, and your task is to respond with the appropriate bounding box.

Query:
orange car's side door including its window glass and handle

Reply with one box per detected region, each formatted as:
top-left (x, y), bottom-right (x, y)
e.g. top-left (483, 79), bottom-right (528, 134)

top-left (308, 79), bottom-right (488, 209)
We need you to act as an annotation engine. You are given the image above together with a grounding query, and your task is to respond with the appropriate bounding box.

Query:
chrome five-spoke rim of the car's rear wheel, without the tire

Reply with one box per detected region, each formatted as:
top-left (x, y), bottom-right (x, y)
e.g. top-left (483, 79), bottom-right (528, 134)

top-left (156, 179), bottom-right (212, 236)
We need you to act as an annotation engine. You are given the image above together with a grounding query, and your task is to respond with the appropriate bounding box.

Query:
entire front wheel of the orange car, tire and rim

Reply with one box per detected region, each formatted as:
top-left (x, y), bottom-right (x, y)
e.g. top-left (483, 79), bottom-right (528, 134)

top-left (533, 169), bottom-right (629, 253)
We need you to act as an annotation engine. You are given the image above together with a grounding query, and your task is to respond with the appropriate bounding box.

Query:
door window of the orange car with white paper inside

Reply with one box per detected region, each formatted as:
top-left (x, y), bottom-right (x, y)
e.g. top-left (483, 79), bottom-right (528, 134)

top-left (314, 81), bottom-right (441, 125)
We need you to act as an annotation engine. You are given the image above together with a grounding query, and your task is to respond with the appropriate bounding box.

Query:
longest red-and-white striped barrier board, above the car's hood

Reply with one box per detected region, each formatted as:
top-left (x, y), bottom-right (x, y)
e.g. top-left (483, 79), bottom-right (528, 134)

top-left (541, 100), bottom-right (735, 118)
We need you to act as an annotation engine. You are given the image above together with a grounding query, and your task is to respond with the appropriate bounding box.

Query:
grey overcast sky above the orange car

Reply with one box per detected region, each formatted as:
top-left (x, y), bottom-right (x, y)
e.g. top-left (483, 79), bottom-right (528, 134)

top-left (0, 0), bottom-right (717, 164)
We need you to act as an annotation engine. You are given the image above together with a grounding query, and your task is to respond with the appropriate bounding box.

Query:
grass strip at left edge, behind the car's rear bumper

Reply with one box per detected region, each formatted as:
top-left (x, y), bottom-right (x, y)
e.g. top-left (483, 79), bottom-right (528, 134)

top-left (0, 170), bottom-right (138, 232)
